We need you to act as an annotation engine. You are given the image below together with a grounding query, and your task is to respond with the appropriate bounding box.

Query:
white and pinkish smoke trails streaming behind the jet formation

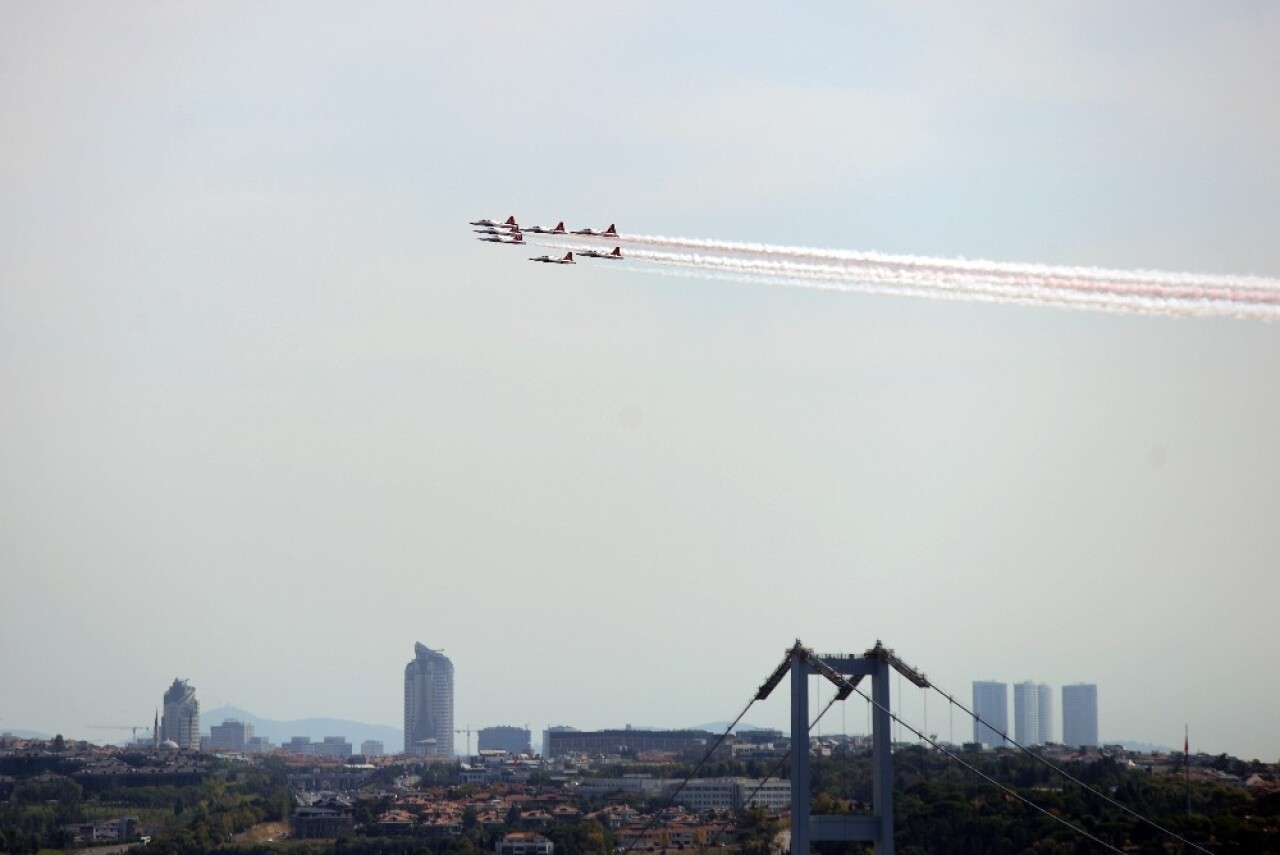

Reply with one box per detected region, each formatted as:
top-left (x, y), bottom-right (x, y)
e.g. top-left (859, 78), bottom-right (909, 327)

top-left (519, 236), bottom-right (1280, 320)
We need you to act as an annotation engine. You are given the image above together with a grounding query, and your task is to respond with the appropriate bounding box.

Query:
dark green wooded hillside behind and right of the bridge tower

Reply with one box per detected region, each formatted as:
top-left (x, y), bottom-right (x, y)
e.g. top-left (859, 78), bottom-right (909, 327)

top-left (812, 747), bottom-right (1280, 855)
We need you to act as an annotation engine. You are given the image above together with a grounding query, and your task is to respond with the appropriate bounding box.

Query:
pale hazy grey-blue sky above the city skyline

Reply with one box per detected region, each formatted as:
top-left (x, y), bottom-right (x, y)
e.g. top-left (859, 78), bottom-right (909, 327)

top-left (0, 1), bottom-right (1280, 760)
